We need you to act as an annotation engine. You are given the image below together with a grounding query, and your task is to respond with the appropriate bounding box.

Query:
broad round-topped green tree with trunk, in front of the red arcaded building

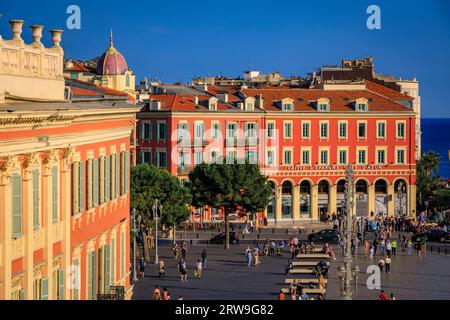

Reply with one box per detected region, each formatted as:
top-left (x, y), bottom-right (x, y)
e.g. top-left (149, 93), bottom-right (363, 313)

top-left (189, 162), bottom-right (272, 248)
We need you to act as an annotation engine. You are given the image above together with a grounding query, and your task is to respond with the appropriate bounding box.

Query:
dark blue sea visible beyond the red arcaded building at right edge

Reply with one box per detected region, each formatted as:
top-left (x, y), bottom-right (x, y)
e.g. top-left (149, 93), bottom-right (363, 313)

top-left (421, 118), bottom-right (450, 178)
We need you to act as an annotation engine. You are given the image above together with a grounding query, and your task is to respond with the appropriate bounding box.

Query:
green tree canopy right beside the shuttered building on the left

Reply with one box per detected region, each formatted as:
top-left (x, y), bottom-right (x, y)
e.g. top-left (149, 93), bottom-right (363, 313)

top-left (131, 163), bottom-right (191, 226)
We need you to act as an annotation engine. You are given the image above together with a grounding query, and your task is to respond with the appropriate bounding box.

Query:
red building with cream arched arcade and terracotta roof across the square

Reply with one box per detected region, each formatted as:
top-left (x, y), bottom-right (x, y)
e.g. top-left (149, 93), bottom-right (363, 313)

top-left (138, 82), bottom-right (415, 224)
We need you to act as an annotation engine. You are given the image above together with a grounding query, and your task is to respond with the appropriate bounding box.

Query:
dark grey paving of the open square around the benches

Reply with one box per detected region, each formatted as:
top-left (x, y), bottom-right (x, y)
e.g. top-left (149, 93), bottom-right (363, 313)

top-left (133, 230), bottom-right (450, 300)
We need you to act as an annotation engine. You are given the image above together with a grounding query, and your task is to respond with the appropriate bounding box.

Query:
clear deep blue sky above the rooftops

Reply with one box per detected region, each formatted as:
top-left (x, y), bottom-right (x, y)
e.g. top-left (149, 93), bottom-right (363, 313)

top-left (0, 0), bottom-right (450, 118)
